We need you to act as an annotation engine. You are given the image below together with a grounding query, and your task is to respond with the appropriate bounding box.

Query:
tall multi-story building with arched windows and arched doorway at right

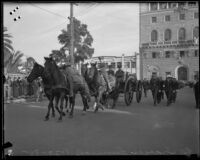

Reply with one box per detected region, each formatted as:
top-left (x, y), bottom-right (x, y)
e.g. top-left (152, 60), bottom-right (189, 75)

top-left (140, 1), bottom-right (199, 80)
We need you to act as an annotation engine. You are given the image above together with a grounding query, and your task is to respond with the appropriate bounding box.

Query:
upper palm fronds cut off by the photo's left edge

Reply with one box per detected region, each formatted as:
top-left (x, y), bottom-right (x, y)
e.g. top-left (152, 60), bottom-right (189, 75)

top-left (3, 27), bottom-right (14, 63)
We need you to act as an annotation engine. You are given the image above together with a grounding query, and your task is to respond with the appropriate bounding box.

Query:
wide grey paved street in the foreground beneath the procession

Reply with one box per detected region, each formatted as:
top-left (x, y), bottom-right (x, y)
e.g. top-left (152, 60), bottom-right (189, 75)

top-left (4, 87), bottom-right (199, 155)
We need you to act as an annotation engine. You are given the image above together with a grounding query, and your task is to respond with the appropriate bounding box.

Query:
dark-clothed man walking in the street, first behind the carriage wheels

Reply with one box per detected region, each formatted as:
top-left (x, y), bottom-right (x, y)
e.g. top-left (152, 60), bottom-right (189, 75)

top-left (150, 77), bottom-right (162, 106)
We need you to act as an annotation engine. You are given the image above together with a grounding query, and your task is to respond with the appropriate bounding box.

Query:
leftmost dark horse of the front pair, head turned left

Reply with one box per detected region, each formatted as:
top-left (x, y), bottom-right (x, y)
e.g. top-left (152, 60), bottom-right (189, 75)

top-left (27, 62), bottom-right (68, 120)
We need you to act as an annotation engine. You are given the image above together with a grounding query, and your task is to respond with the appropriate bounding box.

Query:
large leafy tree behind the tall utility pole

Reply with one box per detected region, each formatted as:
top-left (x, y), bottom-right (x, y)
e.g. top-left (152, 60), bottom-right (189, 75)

top-left (50, 18), bottom-right (94, 63)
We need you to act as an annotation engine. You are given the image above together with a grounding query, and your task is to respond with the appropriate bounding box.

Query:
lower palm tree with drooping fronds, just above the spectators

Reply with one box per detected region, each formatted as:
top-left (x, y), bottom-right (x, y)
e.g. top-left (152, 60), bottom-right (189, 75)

top-left (7, 51), bottom-right (24, 73)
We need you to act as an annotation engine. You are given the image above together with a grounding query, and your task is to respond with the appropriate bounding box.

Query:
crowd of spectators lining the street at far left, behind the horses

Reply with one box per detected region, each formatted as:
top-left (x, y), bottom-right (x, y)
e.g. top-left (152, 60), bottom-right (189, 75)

top-left (4, 76), bottom-right (44, 102)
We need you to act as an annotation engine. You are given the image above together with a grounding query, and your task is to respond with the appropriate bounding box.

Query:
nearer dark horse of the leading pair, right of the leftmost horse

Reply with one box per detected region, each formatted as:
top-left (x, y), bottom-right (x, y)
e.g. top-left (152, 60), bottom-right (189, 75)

top-left (44, 57), bottom-right (89, 120)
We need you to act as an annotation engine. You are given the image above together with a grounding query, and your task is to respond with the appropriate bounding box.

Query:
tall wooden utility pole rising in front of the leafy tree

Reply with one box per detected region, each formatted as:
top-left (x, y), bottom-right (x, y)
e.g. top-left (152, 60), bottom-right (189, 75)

top-left (70, 3), bottom-right (74, 66)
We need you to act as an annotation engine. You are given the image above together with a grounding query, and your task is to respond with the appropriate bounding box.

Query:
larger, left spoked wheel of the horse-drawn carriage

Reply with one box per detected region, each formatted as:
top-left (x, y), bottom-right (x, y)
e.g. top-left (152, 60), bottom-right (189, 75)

top-left (124, 79), bottom-right (134, 106)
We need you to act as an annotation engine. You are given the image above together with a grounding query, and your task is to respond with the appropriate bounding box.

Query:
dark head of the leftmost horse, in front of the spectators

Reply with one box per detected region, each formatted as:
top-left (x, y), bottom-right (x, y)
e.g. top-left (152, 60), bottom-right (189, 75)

top-left (27, 62), bottom-right (44, 83)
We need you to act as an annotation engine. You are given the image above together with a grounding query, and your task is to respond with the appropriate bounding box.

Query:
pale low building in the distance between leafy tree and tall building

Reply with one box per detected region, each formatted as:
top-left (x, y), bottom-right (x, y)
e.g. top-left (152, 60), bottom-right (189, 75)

top-left (85, 55), bottom-right (136, 74)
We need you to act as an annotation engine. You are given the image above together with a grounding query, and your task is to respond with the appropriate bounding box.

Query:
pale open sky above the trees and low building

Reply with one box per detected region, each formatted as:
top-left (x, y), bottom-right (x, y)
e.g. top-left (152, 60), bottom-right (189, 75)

top-left (3, 1), bottom-right (139, 64)
